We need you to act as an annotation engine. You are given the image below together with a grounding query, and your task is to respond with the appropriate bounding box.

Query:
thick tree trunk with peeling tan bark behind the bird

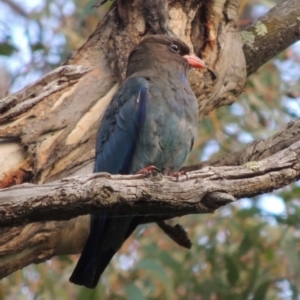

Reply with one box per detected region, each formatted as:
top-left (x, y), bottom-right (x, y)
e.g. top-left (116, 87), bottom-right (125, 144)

top-left (0, 0), bottom-right (246, 188)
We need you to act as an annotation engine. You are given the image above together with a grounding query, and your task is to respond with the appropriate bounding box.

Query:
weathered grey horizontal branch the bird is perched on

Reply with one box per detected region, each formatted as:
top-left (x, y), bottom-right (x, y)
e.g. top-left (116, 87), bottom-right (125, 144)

top-left (0, 141), bottom-right (300, 226)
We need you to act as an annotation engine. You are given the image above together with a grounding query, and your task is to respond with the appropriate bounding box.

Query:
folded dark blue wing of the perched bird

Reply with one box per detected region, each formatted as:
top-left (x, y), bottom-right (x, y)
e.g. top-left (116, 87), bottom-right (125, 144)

top-left (94, 77), bottom-right (148, 174)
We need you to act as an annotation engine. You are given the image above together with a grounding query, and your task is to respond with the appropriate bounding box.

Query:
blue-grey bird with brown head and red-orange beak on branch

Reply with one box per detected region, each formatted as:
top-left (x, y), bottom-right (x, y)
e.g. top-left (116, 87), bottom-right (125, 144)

top-left (70, 35), bottom-right (206, 288)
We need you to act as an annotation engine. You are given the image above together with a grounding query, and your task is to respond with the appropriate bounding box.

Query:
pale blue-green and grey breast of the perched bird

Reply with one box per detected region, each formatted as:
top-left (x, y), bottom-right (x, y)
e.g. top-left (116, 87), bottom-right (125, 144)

top-left (128, 80), bottom-right (198, 173)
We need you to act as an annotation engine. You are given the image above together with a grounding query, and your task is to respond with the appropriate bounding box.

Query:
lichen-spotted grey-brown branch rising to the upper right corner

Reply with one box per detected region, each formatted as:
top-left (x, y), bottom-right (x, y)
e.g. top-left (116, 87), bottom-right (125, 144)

top-left (241, 0), bottom-right (300, 76)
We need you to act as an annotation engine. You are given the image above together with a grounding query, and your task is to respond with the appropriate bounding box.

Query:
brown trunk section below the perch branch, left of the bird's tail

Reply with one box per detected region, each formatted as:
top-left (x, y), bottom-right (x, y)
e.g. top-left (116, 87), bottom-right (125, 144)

top-left (0, 216), bottom-right (89, 278)
